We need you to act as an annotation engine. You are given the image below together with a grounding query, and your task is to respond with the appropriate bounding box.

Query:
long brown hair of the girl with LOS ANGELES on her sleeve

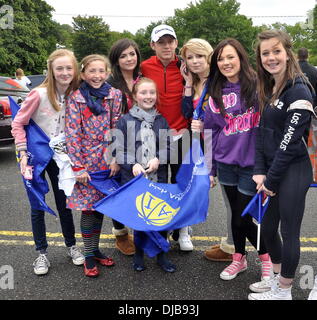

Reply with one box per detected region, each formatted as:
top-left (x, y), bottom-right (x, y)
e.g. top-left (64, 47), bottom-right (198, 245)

top-left (255, 30), bottom-right (307, 112)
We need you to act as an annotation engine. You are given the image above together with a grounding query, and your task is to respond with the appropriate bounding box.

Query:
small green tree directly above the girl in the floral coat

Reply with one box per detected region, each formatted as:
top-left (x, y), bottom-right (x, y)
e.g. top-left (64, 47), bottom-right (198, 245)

top-left (73, 16), bottom-right (111, 60)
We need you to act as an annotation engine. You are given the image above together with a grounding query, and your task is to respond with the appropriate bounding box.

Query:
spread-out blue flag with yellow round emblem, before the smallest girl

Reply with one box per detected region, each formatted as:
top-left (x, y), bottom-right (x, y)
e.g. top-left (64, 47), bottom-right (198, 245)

top-left (93, 139), bottom-right (209, 231)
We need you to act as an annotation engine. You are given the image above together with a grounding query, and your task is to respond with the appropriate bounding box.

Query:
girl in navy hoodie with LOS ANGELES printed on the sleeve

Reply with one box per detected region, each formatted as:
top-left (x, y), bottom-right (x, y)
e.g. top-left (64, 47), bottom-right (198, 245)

top-left (249, 30), bottom-right (314, 300)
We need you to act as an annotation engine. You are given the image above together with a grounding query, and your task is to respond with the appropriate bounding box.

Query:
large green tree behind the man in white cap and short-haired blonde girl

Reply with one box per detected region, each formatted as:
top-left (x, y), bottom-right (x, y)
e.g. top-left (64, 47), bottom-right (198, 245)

top-left (135, 0), bottom-right (259, 59)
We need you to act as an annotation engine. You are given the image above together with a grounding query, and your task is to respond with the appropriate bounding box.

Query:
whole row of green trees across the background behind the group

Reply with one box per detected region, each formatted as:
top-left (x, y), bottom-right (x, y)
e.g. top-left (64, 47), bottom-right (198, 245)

top-left (0, 0), bottom-right (317, 76)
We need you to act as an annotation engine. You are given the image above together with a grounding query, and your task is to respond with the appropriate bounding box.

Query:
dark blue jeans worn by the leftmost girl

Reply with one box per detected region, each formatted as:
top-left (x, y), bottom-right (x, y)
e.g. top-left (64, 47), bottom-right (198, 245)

top-left (31, 160), bottom-right (76, 252)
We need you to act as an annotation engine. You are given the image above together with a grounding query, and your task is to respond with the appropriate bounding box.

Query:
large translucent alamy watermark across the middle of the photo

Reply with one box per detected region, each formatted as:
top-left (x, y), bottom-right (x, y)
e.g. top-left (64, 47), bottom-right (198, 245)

top-left (97, 126), bottom-right (212, 175)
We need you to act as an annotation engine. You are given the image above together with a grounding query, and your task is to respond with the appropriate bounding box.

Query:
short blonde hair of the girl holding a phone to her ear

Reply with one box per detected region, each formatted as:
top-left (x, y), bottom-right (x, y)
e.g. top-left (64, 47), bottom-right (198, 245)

top-left (180, 38), bottom-right (213, 91)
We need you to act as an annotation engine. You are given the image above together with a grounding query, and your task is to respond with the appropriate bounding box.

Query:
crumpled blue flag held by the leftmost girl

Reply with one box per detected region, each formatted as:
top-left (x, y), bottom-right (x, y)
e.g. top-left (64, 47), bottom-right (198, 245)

top-left (9, 96), bottom-right (56, 216)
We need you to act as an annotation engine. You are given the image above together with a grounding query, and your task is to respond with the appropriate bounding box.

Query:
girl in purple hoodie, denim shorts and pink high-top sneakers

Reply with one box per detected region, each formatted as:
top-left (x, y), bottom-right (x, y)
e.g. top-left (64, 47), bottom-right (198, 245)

top-left (196, 38), bottom-right (272, 280)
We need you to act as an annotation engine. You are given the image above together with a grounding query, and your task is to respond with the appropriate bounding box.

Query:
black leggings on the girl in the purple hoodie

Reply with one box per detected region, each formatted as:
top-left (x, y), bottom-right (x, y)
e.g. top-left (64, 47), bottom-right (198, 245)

top-left (224, 185), bottom-right (267, 255)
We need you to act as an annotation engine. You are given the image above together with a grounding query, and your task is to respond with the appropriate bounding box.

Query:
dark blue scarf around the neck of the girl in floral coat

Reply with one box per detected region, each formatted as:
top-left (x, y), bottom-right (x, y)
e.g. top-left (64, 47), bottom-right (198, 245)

top-left (79, 81), bottom-right (111, 116)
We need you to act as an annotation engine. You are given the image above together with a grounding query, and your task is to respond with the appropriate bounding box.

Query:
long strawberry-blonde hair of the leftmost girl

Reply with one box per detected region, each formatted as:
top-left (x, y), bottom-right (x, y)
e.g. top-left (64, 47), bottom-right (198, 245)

top-left (39, 49), bottom-right (79, 111)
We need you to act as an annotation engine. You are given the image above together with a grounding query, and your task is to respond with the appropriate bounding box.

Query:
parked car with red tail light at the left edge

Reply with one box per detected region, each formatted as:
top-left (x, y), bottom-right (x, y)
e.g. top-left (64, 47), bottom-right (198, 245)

top-left (0, 77), bottom-right (30, 145)
